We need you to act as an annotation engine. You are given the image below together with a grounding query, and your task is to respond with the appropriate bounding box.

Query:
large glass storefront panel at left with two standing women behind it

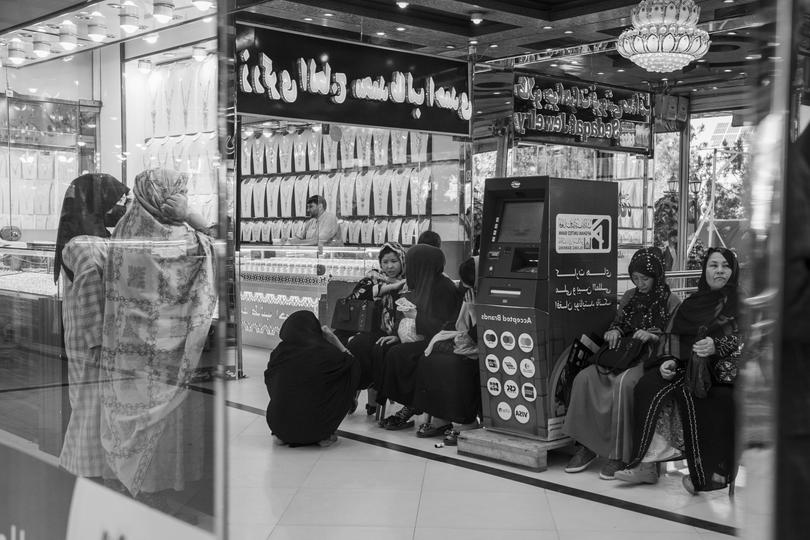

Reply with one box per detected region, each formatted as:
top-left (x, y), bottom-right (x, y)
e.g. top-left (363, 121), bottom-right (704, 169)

top-left (0, 1), bottom-right (224, 539)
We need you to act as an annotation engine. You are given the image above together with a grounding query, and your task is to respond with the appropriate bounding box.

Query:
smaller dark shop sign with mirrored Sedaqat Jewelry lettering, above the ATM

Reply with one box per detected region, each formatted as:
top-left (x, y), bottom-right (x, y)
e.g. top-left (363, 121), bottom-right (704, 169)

top-left (513, 75), bottom-right (652, 154)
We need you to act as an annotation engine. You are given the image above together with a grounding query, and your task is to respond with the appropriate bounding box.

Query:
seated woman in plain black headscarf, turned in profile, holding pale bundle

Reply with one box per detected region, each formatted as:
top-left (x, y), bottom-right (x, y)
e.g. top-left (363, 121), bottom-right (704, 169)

top-left (377, 244), bottom-right (461, 430)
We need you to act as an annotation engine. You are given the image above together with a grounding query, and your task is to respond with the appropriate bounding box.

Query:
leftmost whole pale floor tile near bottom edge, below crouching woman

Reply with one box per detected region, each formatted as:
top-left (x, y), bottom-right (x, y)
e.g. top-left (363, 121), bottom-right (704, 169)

top-left (279, 489), bottom-right (419, 527)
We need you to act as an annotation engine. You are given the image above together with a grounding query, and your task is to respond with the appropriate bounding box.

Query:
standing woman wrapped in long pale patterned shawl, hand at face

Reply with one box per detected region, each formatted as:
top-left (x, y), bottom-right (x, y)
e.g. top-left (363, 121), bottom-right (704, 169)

top-left (101, 169), bottom-right (216, 495)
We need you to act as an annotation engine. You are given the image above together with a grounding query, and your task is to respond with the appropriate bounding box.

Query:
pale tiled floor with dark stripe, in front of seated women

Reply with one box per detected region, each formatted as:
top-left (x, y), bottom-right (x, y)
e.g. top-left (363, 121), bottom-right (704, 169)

top-left (227, 348), bottom-right (744, 540)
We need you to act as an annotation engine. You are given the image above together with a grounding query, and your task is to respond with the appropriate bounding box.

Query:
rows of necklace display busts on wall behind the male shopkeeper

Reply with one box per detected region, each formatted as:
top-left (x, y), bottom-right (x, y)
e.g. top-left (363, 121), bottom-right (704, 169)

top-left (237, 124), bottom-right (462, 245)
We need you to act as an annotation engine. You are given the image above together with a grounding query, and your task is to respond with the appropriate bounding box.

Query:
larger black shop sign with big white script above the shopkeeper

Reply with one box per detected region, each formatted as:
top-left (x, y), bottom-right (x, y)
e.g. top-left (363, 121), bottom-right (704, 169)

top-left (236, 25), bottom-right (472, 135)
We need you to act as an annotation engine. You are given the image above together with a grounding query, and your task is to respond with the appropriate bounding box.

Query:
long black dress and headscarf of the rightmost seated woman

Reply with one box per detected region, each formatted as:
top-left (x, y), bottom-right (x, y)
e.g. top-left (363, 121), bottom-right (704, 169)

top-left (629, 248), bottom-right (742, 491)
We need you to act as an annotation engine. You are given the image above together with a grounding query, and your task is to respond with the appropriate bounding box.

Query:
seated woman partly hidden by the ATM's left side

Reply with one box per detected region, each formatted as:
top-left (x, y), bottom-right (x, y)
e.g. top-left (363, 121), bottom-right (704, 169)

top-left (413, 257), bottom-right (481, 440)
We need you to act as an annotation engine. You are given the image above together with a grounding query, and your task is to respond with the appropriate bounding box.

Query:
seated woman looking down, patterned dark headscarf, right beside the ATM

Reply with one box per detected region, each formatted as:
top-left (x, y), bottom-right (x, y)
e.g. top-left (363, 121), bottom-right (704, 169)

top-left (563, 248), bottom-right (680, 480)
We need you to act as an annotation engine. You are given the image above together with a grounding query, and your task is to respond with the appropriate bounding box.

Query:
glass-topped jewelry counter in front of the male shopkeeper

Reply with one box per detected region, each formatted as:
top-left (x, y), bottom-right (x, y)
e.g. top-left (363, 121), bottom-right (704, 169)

top-left (238, 246), bottom-right (378, 349)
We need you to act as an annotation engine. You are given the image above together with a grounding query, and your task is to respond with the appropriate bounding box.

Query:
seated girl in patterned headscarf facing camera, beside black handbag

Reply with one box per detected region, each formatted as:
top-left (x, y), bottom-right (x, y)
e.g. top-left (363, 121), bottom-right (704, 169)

top-left (346, 242), bottom-right (405, 414)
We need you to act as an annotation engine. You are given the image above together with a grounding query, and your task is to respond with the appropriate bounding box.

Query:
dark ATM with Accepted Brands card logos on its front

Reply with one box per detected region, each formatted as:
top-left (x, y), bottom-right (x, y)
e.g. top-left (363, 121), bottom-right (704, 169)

top-left (476, 176), bottom-right (618, 441)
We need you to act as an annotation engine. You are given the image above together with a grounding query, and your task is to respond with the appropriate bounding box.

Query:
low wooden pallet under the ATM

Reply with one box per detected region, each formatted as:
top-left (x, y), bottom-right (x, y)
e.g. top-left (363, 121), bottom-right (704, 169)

top-left (458, 429), bottom-right (574, 472)
